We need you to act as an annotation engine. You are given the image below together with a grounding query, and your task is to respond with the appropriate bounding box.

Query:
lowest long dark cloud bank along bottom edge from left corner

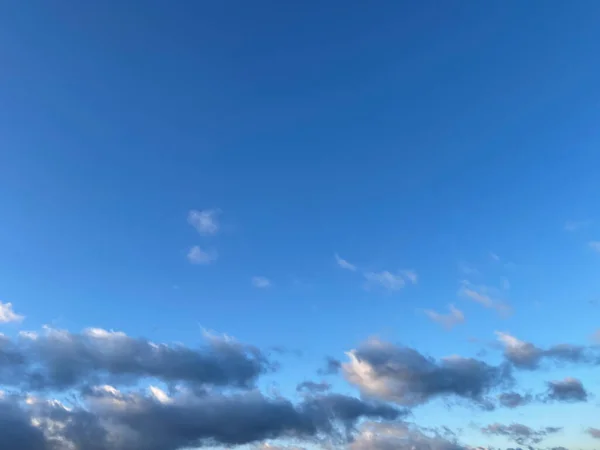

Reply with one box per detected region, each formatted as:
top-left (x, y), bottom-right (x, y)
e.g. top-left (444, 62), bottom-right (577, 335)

top-left (0, 386), bottom-right (405, 450)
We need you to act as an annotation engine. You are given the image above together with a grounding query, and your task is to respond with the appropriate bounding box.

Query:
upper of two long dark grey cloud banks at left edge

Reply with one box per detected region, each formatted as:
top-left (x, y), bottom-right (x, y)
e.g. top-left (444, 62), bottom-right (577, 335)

top-left (0, 329), bottom-right (273, 390)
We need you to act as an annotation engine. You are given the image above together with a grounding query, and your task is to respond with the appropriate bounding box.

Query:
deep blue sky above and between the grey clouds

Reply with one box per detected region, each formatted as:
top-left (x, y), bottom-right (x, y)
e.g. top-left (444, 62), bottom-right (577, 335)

top-left (0, 0), bottom-right (600, 450)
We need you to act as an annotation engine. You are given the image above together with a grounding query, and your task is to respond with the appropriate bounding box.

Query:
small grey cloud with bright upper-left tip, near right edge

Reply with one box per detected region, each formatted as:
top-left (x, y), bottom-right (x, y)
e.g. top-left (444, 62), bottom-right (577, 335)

top-left (496, 332), bottom-right (594, 370)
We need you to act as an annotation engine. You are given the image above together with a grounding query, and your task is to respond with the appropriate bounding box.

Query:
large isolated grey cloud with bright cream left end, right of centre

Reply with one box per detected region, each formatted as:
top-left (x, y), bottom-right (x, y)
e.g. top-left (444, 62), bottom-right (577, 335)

top-left (342, 338), bottom-right (512, 408)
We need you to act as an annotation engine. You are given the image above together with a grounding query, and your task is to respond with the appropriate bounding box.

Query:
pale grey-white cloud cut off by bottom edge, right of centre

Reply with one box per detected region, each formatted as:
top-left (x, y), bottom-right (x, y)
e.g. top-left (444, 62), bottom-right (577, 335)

top-left (349, 422), bottom-right (468, 450)
